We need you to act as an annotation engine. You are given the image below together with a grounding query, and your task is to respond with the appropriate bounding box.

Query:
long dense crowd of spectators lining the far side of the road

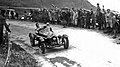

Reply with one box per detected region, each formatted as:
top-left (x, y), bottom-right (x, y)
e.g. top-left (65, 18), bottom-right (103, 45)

top-left (0, 3), bottom-right (120, 38)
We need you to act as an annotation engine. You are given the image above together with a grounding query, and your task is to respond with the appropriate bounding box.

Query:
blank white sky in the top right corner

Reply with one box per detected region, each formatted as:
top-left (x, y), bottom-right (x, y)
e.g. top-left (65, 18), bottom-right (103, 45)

top-left (88, 0), bottom-right (120, 12)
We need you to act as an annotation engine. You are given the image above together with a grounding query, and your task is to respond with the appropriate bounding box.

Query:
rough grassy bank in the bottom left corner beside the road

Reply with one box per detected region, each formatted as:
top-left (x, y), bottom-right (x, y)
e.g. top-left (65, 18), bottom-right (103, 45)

top-left (0, 43), bottom-right (37, 67)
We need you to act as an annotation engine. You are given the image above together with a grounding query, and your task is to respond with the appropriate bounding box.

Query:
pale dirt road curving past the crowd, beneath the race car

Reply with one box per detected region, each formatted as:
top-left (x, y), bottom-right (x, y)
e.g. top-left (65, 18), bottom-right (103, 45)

top-left (8, 21), bottom-right (120, 67)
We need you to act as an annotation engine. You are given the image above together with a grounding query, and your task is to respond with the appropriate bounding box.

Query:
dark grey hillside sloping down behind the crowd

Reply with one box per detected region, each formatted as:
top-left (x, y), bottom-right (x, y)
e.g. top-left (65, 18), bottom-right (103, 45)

top-left (0, 0), bottom-right (95, 9)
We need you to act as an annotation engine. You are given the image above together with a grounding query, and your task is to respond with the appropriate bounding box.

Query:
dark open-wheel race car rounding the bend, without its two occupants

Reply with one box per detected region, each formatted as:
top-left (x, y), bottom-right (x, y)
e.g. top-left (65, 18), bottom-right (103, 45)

top-left (29, 29), bottom-right (69, 54)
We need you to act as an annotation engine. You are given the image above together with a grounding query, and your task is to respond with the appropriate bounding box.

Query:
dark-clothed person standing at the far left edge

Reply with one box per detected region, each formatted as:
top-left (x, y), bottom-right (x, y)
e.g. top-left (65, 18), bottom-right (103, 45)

top-left (0, 12), bottom-right (11, 47)
